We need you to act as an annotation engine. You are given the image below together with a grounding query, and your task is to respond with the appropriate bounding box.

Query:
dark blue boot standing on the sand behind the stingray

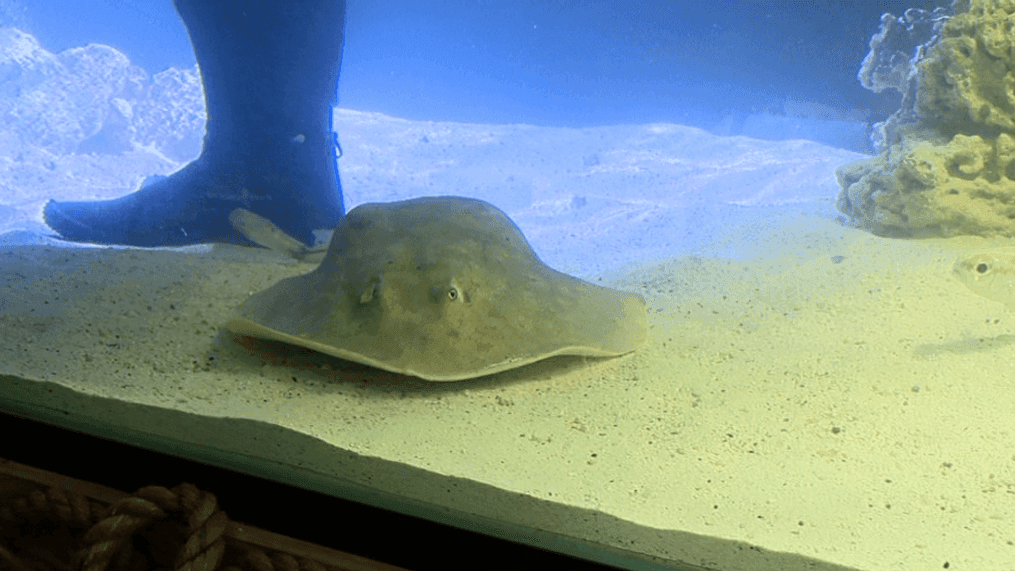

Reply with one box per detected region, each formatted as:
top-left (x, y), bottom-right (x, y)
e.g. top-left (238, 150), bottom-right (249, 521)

top-left (44, 0), bottom-right (345, 246)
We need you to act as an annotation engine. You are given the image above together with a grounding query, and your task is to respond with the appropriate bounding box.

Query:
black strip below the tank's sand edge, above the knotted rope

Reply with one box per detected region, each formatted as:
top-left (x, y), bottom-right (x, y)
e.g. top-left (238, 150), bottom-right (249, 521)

top-left (0, 415), bottom-right (613, 571)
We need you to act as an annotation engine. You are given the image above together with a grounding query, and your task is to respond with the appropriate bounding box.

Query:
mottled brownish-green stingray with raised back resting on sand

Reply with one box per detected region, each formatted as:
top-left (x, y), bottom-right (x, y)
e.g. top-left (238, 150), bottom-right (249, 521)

top-left (226, 197), bottom-right (647, 381)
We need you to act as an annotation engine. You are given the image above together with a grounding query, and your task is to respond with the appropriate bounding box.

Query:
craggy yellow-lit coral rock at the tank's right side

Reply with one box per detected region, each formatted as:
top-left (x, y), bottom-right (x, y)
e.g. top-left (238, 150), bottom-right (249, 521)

top-left (836, 0), bottom-right (1015, 237)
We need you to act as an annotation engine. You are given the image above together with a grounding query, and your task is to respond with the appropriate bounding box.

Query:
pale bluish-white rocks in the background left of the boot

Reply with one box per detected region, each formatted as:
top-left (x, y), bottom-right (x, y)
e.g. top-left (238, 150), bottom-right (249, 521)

top-left (0, 27), bottom-right (205, 162)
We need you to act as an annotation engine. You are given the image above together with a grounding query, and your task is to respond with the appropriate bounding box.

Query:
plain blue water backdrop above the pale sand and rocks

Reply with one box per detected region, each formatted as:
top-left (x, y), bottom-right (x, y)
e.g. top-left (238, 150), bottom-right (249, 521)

top-left (0, 0), bottom-right (945, 151)
